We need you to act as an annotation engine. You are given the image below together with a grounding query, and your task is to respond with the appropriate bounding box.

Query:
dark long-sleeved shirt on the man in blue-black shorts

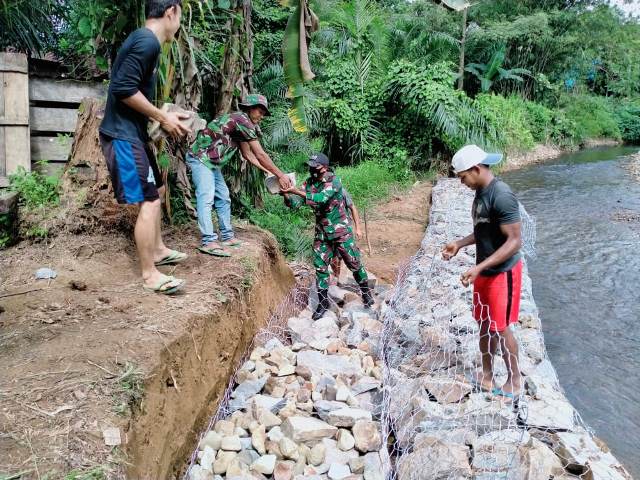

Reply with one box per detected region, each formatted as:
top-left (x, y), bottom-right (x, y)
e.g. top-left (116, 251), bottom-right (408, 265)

top-left (100, 28), bottom-right (160, 143)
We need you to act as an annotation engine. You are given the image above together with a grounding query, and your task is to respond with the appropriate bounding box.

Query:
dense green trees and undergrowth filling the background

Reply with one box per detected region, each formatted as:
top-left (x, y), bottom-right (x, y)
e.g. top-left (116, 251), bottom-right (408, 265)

top-left (0, 0), bottom-right (640, 255)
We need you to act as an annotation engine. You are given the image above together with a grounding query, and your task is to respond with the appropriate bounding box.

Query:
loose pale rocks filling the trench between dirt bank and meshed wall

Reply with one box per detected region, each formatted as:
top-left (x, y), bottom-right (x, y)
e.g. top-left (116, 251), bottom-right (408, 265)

top-left (188, 274), bottom-right (390, 480)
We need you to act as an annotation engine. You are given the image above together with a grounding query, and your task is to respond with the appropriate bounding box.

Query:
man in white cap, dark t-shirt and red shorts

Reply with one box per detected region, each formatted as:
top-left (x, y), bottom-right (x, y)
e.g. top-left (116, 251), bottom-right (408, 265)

top-left (442, 145), bottom-right (522, 400)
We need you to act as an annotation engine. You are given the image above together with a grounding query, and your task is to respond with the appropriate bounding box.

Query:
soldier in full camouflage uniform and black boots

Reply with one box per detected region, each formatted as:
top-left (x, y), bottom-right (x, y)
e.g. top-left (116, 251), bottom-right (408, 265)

top-left (285, 153), bottom-right (374, 320)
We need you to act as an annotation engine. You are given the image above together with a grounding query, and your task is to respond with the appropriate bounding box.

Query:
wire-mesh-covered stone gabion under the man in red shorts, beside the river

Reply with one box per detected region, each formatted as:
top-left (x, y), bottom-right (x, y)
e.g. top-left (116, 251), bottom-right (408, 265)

top-left (382, 180), bottom-right (631, 480)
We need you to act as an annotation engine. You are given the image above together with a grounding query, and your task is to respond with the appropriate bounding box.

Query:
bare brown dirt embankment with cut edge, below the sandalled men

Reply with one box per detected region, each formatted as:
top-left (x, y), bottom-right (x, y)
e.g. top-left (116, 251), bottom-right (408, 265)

top-left (0, 228), bottom-right (294, 480)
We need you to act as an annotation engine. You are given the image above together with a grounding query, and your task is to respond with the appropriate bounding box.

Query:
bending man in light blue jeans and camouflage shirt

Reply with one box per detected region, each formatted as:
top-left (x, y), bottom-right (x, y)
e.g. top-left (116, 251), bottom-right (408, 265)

top-left (186, 94), bottom-right (291, 257)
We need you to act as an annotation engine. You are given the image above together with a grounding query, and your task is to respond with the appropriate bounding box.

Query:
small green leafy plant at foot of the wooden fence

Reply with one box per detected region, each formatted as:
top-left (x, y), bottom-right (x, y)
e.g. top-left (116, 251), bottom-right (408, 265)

top-left (9, 167), bottom-right (60, 209)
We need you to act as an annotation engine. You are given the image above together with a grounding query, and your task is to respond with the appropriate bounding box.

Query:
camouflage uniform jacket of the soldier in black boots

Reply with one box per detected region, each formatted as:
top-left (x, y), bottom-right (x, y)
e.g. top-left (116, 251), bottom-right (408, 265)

top-left (287, 172), bottom-right (353, 240)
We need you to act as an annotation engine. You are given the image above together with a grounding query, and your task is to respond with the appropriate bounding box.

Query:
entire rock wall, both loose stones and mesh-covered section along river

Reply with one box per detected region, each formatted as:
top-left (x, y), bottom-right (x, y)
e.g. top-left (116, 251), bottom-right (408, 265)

top-left (186, 180), bottom-right (631, 480)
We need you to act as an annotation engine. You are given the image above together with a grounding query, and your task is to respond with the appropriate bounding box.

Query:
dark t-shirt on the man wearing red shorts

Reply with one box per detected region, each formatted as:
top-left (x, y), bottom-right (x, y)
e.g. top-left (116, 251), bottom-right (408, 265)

top-left (471, 178), bottom-right (520, 276)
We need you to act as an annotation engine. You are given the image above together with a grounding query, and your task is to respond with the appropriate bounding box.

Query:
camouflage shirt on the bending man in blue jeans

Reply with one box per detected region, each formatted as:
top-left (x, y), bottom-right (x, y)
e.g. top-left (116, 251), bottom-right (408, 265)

top-left (190, 112), bottom-right (262, 168)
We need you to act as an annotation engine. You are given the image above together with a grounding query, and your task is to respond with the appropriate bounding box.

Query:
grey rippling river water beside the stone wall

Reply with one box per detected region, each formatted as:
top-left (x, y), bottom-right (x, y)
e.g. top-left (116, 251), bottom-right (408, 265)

top-left (502, 147), bottom-right (640, 479)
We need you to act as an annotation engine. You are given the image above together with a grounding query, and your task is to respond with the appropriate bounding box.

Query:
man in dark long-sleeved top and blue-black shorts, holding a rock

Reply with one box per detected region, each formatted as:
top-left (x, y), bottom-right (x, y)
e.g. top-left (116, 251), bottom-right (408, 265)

top-left (100, 0), bottom-right (189, 294)
